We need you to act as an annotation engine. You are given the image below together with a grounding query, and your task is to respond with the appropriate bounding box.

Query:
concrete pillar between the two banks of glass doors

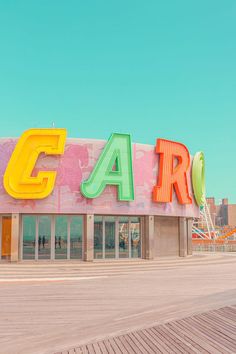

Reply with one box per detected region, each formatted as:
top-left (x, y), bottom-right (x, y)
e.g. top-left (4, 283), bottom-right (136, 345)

top-left (84, 214), bottom-right (94, 262)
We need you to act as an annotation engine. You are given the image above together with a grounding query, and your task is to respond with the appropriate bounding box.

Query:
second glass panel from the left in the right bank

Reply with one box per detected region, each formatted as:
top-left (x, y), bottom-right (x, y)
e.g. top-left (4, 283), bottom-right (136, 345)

top-left (104, 216), bottom-right (116, 258)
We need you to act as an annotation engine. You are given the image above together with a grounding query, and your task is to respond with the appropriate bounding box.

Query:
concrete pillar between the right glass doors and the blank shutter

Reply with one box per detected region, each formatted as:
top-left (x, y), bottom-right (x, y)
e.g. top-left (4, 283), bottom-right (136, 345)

top-left (143, 215), bottom-right (155, 260)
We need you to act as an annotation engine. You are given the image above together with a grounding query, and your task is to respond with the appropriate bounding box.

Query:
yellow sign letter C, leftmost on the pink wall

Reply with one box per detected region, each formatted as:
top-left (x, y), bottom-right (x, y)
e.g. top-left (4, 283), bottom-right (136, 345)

top-left (4, 128), bottom-right (66, 199)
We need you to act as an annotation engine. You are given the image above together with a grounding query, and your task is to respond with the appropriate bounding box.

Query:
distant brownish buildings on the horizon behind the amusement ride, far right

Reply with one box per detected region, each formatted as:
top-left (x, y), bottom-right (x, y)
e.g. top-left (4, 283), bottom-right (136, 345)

top-left (207, 197), bottom-right (236, 228)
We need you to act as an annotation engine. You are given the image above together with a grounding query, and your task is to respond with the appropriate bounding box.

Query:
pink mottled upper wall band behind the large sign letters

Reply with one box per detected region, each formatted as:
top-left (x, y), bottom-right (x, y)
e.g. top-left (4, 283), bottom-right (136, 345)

top-left (0, 138), bottom-right (199, 217)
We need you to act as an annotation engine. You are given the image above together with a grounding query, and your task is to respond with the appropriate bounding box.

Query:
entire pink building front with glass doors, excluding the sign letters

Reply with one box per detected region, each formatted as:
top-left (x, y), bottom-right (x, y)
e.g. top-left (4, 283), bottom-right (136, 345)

top-left (0, 138), bottom-right (199, 261)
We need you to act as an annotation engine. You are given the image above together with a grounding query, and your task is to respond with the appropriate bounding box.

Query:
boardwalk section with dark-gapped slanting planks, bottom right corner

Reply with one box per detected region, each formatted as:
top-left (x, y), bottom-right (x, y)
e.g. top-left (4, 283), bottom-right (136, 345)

top-left (56, 305), bottom-right (236, 354)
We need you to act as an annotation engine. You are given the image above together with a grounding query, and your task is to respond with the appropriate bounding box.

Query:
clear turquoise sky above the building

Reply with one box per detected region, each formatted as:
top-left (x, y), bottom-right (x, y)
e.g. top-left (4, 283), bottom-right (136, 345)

top-left (0, 0), bottom-right (236, 202)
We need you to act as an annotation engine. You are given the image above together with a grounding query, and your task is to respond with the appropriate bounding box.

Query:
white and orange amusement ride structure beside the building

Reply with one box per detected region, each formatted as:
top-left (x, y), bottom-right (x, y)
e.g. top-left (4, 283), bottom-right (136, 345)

top-left (192, 202), bottom-right (236, 241)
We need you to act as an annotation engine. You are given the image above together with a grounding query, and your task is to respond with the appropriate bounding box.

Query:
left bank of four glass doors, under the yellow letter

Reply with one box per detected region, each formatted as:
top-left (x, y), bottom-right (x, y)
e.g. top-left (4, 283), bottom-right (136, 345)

top-left (22, 214), bottom-right (83, 260)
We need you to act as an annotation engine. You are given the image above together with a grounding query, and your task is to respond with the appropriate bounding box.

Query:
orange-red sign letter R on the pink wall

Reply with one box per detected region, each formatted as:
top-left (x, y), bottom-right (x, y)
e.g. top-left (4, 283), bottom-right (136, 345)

top-left (153, 139), bottom-right (192, 204)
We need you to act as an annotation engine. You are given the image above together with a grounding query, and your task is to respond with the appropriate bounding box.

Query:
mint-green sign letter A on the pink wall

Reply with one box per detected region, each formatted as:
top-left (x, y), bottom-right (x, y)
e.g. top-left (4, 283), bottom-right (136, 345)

top-left (81, 134), bottom-right (134, 201)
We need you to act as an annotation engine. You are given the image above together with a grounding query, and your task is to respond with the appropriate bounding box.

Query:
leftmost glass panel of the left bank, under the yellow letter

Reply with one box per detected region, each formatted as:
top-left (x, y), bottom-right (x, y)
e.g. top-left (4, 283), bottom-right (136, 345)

top-left (23, 215), bottom-right (36, 259)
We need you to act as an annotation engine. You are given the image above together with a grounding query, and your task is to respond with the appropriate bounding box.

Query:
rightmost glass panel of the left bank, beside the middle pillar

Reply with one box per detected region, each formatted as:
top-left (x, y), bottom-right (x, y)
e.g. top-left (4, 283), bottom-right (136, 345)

top-left (70, 215), bottom-right (83, 259)
